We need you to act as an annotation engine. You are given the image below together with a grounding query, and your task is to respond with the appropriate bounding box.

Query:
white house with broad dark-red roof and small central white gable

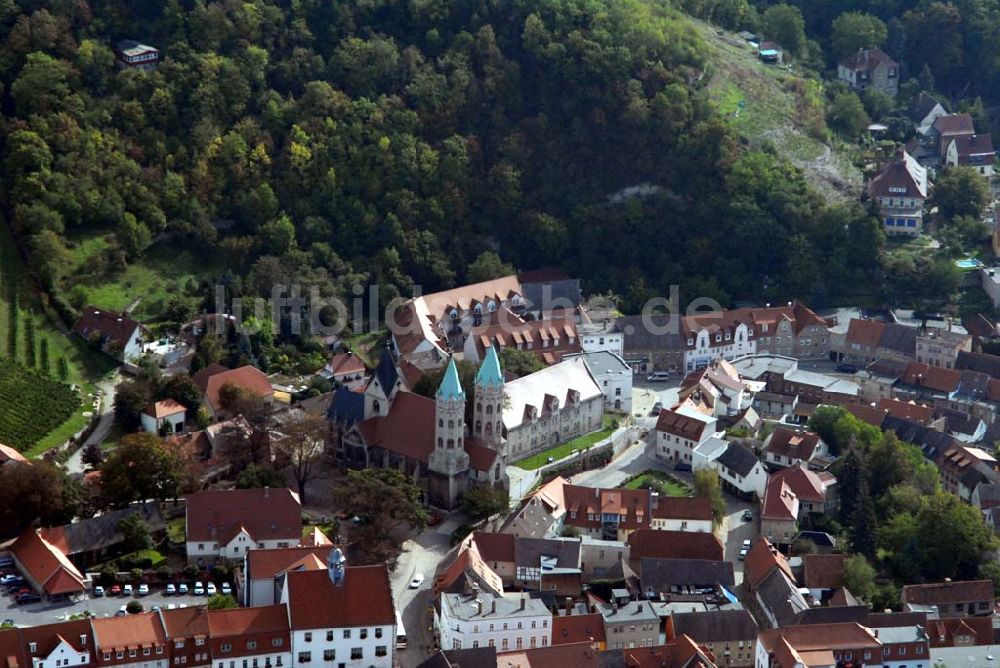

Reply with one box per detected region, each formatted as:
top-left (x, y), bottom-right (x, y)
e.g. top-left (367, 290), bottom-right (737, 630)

top-left (185, 487), bottom-right (302, 563)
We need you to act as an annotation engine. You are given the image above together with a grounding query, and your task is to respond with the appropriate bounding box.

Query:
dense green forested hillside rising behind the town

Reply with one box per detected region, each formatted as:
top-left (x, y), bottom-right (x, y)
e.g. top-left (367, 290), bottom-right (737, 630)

top-left (0, 0), bottom-right (882, 319)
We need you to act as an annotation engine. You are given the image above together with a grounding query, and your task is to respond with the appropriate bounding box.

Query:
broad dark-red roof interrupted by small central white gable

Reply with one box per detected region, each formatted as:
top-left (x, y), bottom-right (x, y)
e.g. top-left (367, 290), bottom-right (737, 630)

top-left (187, 487), bottom-right (302, 544)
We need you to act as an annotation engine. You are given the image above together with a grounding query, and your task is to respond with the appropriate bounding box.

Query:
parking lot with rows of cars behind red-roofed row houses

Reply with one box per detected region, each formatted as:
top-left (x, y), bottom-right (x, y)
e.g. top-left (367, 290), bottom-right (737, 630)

top-left (0, 583), bottom-right (230, 626)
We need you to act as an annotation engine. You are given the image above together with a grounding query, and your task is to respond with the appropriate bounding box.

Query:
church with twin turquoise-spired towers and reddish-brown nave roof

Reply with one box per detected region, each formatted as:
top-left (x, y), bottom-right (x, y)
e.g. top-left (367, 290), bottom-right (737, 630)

top-left (331, 347), bottom-right (507, 509)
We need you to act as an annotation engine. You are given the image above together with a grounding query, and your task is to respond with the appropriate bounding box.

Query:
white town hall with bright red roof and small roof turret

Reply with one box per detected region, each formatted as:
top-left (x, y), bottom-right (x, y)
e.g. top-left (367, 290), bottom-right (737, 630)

top-left (281, 549), bottom-right (396, 668)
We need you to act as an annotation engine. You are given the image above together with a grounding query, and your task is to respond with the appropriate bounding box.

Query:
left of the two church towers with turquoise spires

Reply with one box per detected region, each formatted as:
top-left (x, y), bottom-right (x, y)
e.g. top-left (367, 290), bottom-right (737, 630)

top-left (427, 359), bottom-right (469, 508)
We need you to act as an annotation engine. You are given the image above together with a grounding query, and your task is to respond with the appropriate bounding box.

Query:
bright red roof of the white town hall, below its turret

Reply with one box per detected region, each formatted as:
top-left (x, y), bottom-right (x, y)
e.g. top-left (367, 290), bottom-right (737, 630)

top-left (287, 564), bottom-right (396, 630)
